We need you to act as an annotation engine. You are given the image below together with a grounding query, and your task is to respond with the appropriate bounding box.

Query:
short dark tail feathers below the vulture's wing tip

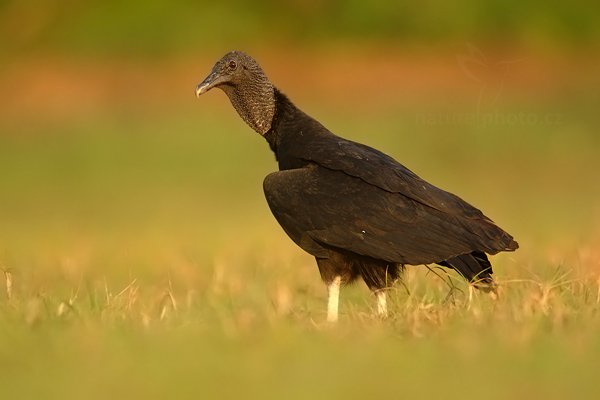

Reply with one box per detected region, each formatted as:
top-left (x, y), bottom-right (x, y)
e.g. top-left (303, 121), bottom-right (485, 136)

top-left (439, 251), bottom-right (496, 292)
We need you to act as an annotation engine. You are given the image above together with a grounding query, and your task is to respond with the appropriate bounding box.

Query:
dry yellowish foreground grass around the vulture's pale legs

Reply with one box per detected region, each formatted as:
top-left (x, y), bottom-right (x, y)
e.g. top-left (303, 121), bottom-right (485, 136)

top-left (0, 238), bottom-right (600, 398)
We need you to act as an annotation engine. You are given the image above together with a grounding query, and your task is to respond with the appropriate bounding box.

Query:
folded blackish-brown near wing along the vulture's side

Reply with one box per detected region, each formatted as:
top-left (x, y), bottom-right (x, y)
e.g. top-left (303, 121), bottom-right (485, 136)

top-left (264, 164), bottom-right (514, 264)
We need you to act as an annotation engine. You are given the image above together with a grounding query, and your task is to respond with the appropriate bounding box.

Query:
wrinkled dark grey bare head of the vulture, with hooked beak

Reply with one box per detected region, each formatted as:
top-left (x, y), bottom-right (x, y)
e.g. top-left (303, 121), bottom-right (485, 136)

top-left (196, 51), bottom-right (275, 135)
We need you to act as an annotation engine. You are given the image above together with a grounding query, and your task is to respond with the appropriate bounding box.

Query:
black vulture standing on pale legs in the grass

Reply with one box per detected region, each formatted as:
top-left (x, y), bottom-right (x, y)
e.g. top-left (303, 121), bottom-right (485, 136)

top-left (196, 51), bottom-right (518, 321)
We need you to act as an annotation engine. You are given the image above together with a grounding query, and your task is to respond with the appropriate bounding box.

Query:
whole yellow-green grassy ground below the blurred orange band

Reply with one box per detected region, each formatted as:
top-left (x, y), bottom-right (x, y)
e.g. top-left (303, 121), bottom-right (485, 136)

top-left (0, 54), bottom-right (600, 399)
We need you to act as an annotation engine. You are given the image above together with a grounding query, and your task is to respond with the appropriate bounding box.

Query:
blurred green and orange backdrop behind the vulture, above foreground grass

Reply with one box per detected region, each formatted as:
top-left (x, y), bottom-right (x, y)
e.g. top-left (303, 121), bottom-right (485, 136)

top-left (0, 0), bottom-right (600, 282)
